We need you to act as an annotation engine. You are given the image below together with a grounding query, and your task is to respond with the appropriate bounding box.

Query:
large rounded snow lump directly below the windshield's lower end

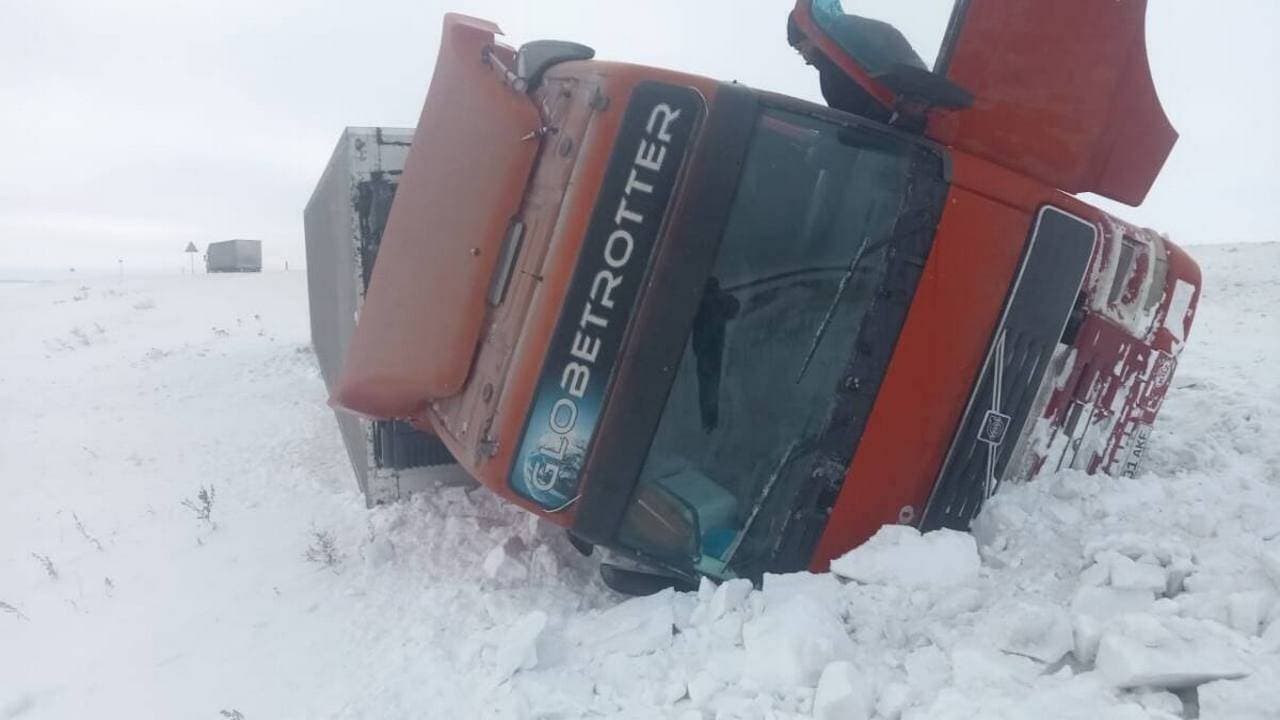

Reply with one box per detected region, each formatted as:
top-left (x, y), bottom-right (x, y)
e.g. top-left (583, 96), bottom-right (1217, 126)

top-left (742, 594), bottom-right (854, 689)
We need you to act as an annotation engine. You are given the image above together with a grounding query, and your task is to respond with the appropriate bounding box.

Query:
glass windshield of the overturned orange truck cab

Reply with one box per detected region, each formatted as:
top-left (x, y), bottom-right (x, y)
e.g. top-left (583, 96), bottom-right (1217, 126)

top-left (618, 109), bottom-right (918, 577)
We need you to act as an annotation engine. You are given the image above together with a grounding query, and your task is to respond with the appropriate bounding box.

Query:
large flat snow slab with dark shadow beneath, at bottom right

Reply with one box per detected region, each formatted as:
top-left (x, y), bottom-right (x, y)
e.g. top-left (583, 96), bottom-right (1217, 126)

top-left (1096, 615), bottom-right (1248, 689)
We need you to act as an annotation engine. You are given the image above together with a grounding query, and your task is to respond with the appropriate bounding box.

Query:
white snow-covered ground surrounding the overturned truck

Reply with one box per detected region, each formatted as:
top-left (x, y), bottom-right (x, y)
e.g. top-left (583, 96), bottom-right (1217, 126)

top-left (0, 243), bottom-right (1280, 720)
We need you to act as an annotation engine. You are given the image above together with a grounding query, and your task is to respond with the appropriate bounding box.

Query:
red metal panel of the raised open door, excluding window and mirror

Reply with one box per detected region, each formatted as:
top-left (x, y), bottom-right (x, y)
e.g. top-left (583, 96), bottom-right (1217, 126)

top-left (928, 0), bottom-right (1178, 205)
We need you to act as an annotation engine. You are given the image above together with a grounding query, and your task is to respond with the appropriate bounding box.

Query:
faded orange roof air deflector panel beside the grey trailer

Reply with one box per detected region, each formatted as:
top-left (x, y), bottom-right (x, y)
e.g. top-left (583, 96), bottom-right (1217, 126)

top-left (333, 14), bottom-right (541, 418)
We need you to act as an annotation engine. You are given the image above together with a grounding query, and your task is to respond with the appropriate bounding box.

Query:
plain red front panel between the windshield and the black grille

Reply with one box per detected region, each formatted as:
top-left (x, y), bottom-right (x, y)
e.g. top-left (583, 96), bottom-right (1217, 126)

top-left (812, 187), bottom-right (1032, 571)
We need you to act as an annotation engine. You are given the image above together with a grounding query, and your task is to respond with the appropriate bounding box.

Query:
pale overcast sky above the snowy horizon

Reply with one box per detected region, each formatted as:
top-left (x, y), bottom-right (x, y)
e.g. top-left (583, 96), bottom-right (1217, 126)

top-left (0, 0), bottom-right (1280, 270)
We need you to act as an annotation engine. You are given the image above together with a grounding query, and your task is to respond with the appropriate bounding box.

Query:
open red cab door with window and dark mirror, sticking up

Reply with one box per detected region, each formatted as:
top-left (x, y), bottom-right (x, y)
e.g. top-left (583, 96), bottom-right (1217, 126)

top-left (791, 0), bottom-right (1178, 205)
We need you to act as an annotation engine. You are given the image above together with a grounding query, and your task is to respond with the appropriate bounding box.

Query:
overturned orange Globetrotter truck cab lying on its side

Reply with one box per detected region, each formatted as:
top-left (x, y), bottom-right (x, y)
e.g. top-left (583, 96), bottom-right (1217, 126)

top-left (307, 0), bottom-right (1201, 592)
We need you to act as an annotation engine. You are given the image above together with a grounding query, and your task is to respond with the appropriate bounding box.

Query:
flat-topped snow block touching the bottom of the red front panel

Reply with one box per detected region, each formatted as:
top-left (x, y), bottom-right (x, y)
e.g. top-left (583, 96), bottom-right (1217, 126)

top-left (831, 525), bottom-right (982, 588)
